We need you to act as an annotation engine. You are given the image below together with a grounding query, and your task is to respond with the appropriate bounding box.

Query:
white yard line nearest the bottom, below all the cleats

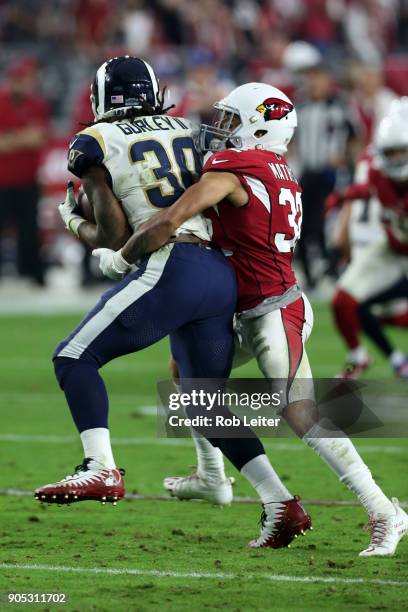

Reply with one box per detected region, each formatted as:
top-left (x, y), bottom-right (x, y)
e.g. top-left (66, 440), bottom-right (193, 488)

top-left (0, 563), bottom-right (408, 586)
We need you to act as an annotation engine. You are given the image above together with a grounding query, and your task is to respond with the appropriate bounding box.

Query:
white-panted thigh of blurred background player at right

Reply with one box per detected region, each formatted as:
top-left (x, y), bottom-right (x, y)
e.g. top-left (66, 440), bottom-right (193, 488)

top-left (337, 239), bottom-right (403, 302)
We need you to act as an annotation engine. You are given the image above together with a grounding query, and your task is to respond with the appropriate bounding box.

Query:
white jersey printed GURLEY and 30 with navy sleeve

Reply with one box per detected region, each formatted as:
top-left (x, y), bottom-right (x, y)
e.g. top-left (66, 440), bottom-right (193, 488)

top-left (68, 115), bottom-right (211, 240)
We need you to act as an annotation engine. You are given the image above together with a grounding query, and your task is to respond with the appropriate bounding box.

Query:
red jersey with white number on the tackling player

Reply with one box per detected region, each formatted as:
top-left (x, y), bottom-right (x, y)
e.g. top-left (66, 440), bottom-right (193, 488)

top-left (203, 149), bottom-right (302, 312)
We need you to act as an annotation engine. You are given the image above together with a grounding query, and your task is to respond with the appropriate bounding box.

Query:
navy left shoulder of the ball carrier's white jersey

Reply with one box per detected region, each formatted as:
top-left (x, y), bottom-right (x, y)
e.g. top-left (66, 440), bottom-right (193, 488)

top-left (68, 126), bottom-right (106, 178)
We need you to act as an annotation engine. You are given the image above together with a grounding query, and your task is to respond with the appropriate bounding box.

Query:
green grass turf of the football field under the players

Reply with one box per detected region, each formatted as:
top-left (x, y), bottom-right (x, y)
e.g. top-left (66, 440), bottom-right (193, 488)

top-left (0, 306), bottom-right (408, 612)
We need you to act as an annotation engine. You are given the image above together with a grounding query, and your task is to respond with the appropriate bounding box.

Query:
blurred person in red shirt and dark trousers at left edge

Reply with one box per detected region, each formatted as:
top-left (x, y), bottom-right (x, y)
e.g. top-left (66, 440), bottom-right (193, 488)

top-left (0, 59), bottom-right (48, 285)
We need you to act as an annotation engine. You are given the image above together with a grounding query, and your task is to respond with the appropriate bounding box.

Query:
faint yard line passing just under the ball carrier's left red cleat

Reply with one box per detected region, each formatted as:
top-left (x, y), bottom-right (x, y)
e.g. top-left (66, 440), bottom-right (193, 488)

top-left (0, 489), bottom-right (408, 508)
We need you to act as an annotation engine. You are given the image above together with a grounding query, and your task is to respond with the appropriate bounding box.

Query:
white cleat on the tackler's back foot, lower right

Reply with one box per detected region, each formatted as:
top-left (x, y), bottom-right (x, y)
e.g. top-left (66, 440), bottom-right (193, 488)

top-left (359, 497), bottom-right (408, 557)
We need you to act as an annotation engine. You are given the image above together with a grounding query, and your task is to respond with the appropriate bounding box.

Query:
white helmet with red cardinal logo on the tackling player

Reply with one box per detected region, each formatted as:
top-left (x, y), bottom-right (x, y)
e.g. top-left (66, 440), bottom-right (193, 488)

top-left (200, 83), bottom-right (297, 155)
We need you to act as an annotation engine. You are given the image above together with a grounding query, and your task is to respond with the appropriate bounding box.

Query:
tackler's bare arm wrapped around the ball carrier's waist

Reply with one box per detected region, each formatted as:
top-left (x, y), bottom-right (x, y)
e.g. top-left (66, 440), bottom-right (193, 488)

top-left (121, 172), bottom-right (248, 263)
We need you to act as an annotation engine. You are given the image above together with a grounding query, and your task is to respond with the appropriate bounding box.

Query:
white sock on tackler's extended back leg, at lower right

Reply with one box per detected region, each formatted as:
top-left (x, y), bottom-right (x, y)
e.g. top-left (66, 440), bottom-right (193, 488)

top-left (303, 424), bottom-right (395, 516)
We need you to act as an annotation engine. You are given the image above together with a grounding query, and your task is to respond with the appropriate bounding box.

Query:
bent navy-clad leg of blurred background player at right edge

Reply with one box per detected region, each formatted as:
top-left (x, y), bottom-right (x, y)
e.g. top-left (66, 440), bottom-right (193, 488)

top-left (358, 276), bottom-right (408, 378)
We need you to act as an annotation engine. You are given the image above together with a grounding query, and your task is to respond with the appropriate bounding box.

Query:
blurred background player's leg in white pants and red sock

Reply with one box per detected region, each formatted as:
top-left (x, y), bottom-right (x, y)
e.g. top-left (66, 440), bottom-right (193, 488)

top-left (332, 240), bottom-right (401, 378)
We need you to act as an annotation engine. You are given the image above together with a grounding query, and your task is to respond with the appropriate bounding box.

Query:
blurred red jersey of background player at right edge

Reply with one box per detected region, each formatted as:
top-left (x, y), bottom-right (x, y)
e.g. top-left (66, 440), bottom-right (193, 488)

top-left (344, 161), bottom-right (408, 255)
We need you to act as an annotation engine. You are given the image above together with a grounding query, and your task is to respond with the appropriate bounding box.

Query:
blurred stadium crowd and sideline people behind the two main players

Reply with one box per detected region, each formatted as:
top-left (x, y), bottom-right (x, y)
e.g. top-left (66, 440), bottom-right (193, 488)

top-left (0, 0), bottom-right (408, 288)
